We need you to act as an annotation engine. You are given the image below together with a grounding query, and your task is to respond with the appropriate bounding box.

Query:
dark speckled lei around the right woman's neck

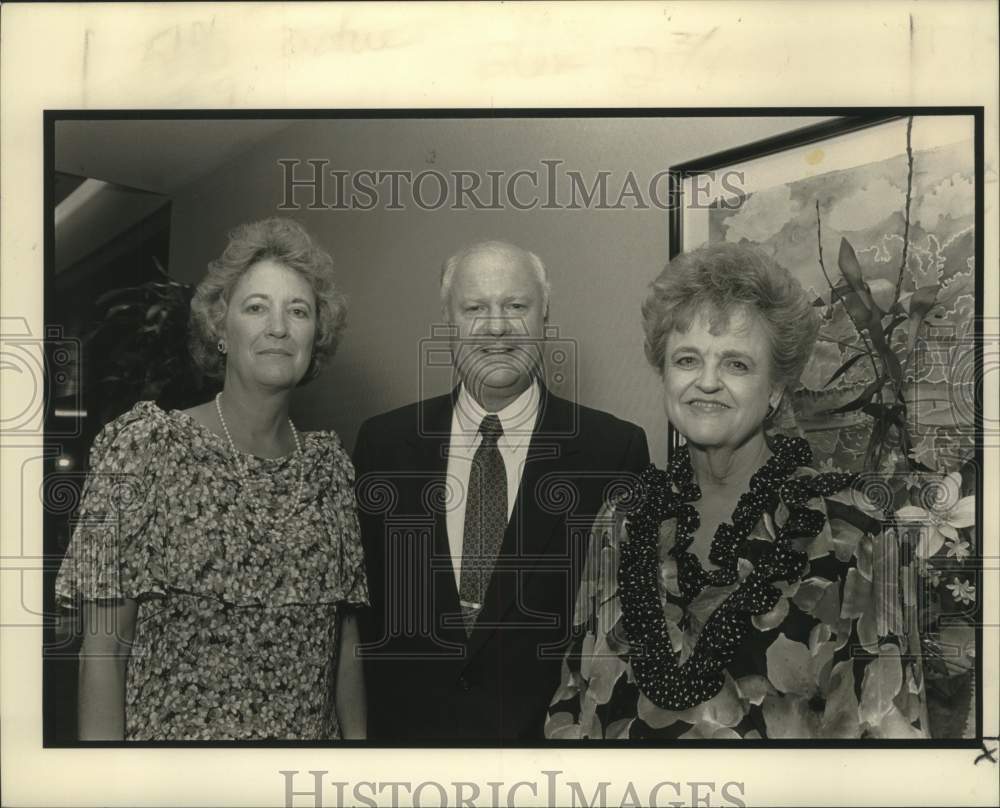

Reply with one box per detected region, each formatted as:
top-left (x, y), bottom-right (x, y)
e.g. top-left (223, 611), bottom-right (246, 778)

top-left (618, 435), bottom-right (852, 710)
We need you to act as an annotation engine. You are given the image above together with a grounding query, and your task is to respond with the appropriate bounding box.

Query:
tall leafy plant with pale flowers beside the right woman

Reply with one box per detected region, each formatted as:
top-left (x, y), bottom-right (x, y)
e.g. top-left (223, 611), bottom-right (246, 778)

top-left (816, 117), bottom-right (979, 737)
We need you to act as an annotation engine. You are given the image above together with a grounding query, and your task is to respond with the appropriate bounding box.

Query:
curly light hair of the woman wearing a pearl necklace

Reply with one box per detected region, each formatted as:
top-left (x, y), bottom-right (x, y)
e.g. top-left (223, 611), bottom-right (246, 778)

top-left (190, 218), bottom-right (347, 384)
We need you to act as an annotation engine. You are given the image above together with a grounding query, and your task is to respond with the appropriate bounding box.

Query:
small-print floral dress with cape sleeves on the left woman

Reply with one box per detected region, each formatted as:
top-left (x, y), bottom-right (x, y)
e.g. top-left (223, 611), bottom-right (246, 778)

top-left (56, 401), bottom-right (368, 740)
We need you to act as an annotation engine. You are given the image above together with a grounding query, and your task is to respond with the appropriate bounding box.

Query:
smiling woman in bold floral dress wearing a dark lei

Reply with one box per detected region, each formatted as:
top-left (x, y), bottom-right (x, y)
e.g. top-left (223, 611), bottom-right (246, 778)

top-left (546, 244), bottom-right (926, 739)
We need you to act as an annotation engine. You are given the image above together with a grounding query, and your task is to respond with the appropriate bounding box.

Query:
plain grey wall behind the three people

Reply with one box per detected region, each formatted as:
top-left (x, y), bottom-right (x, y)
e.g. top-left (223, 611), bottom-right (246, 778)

top-left (170, 117), bottom-right (820, 464)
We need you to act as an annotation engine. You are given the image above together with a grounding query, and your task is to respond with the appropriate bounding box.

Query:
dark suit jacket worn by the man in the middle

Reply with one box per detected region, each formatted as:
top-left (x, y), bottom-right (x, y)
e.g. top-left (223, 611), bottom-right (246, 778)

top-left (354, 387), bottom-right (649, 744)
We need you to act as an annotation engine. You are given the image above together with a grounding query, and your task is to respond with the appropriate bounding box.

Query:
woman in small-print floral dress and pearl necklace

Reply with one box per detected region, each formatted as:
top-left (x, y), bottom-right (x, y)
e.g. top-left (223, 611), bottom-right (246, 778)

top-left (56, 219), bottom-right (367, 741)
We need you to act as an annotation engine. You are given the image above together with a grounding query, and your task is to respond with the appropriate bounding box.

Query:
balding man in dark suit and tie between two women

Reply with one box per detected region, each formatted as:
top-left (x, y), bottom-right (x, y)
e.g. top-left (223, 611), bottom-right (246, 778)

top-left (354, 242), bottom-right (649, 744)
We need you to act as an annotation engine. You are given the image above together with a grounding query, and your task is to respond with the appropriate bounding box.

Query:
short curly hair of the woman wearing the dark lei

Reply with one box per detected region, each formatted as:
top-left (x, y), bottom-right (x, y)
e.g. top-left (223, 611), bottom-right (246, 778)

top-left (642, 242), bottom-right (820, 385)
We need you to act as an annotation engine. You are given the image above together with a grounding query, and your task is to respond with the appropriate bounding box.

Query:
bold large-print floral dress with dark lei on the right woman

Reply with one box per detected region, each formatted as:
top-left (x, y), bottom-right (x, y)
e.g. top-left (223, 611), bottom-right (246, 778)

top-left (545, 436), bottom-right (927, 740)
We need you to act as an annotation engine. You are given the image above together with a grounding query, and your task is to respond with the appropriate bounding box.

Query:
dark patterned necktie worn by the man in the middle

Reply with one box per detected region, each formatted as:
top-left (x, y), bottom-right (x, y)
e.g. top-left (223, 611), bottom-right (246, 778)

top-left (458, 415), bottom-right (507, 634)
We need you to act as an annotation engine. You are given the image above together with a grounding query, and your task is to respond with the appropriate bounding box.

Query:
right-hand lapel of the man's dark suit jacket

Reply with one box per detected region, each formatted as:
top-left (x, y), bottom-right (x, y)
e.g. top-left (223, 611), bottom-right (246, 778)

top-left (469, 386), bottom-right (579, 657)
